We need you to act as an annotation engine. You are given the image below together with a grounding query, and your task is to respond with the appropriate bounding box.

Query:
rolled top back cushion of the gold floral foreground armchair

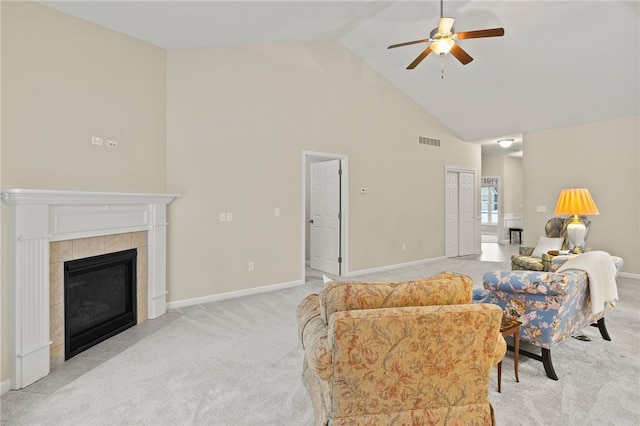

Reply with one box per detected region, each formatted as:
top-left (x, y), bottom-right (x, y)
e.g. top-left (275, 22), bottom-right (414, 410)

top-left (320, 272), bottom-right (473, 323)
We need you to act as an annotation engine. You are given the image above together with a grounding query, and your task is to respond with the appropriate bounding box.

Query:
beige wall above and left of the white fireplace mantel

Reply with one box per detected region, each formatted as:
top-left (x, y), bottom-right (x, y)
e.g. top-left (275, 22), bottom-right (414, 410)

top-left (0, 1), bottom-right (166, 381)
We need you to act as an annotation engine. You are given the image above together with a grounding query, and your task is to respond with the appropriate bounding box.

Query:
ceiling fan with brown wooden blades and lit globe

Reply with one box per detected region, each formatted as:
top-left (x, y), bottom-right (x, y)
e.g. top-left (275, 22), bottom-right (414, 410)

top-left (387, 0), bottom-right (504, 70)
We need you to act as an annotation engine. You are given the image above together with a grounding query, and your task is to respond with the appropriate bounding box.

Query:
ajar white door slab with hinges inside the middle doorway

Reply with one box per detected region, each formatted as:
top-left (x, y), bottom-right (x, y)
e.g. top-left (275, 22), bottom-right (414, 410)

top-left (309, 160), bottom-right (341, 275)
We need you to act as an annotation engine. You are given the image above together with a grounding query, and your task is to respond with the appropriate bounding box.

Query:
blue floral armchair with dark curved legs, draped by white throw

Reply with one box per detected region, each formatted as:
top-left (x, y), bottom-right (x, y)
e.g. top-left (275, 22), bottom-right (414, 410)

top-left (474, 252), bottom-right (623, 380)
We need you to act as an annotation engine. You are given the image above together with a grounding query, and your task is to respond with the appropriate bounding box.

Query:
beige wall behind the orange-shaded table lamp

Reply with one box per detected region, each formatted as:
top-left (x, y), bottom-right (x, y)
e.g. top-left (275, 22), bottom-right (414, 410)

top-left (523, 116), bottom-right (640, 274)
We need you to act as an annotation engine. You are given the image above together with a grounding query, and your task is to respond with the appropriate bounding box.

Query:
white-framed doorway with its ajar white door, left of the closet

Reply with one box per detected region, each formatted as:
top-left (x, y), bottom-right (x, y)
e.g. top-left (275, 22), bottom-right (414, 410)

top-left (302, 152), bottom-right (349, 279)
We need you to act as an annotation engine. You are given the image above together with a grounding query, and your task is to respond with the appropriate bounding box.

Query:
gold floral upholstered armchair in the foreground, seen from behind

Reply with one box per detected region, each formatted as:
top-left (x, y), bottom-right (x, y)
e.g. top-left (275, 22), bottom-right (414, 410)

top-left (297, 272), bottom-right (506, 425)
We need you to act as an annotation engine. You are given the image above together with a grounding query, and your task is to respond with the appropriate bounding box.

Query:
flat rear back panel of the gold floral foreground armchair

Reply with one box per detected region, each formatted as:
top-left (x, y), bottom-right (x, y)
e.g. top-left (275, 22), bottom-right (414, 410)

top-left (329, 304), bottom-right (506, 420)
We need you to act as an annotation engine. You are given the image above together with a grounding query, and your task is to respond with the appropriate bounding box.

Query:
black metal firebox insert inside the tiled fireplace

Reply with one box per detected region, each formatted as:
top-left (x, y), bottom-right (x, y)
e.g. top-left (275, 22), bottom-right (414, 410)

top-left (64, 249), bottom-right (137, 360)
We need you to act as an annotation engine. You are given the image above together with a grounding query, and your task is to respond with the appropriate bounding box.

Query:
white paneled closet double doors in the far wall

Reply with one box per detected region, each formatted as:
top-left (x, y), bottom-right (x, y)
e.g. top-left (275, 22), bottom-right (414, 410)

top-left (445, 167), bottom-right (476, 257)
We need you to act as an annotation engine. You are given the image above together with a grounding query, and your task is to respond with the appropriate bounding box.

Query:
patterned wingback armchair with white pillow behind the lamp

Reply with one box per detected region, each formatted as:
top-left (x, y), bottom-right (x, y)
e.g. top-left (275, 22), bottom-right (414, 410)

top-left (511, 216), bottom-right (591, 271)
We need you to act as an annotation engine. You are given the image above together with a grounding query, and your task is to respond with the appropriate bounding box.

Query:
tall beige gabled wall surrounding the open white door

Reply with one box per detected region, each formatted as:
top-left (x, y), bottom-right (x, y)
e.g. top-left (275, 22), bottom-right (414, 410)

top-left (167, 43), bottom-right (480, 301)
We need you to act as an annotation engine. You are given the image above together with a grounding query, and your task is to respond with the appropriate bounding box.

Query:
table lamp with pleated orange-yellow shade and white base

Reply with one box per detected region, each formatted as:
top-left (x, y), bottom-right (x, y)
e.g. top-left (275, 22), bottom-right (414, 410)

top-left (555, 188), bottom-right (600, 253)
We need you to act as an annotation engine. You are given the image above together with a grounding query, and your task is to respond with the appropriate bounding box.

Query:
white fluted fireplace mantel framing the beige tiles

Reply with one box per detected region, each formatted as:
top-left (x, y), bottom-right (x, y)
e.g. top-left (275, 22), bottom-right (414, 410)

top-left (2, 189), bottom-right (176, 389)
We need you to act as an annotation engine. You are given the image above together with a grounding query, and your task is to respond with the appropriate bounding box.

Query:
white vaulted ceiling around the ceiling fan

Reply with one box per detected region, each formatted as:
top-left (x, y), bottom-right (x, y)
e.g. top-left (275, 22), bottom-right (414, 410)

top-left (39, 0), bottom-right (640, 151)
